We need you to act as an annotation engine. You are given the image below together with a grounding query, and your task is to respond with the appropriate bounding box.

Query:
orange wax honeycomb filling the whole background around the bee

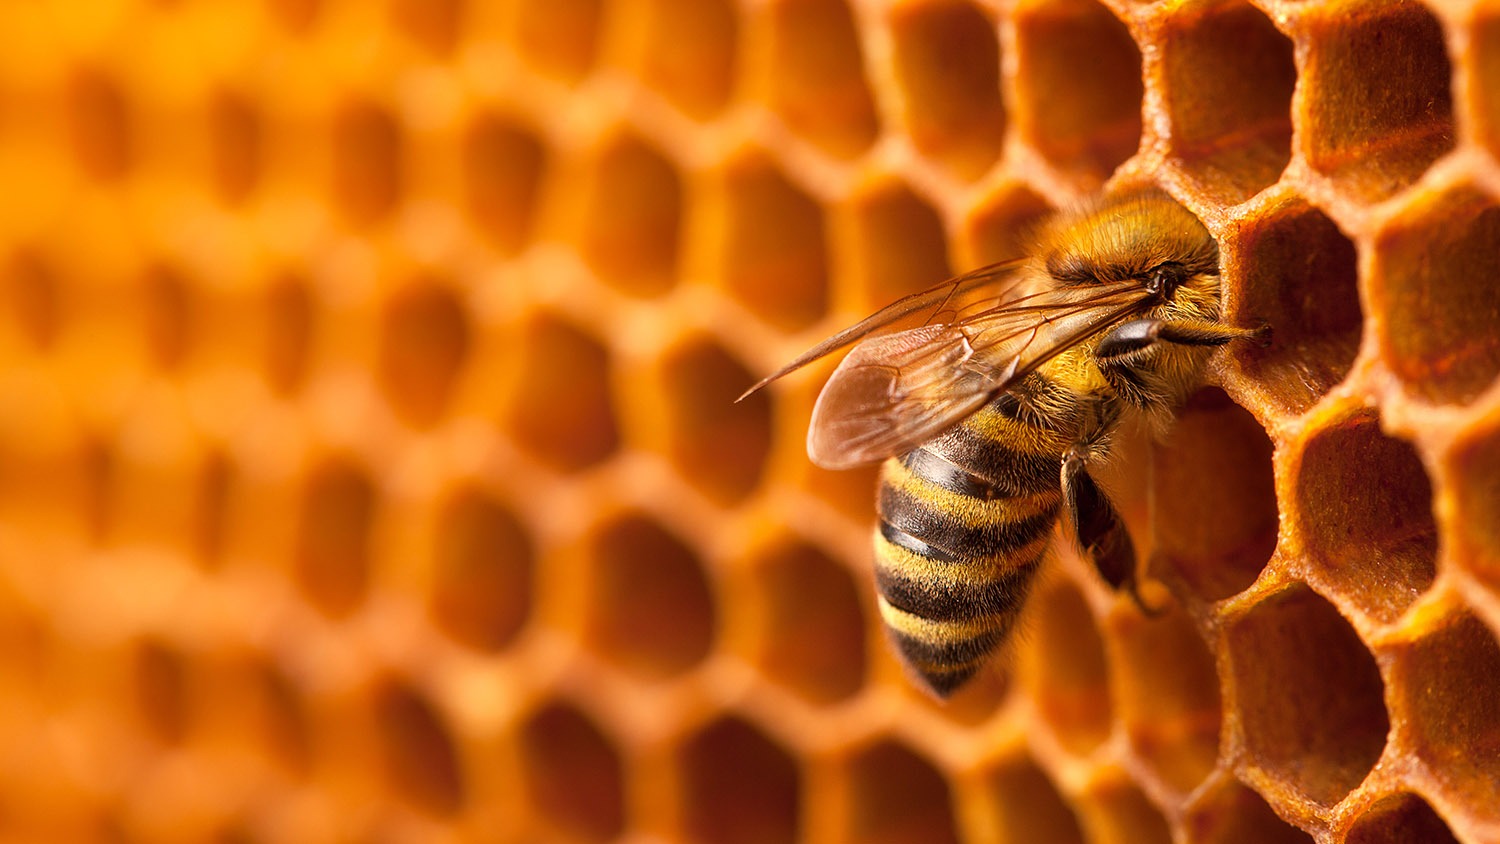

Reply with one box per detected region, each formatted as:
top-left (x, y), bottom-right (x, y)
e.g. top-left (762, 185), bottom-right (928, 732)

top-left (0, 0), bottom-right (1500, 844)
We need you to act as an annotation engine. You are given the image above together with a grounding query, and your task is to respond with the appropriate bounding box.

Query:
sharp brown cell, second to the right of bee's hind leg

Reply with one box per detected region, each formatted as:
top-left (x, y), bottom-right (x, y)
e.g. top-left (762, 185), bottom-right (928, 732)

top-left (1293, 415), bottom-right (1437, 624)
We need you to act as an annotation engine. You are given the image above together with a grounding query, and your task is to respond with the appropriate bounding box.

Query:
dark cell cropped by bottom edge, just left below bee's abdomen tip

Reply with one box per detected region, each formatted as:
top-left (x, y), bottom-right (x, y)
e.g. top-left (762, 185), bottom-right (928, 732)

top-left (846, 741), bottom-right (959, 844)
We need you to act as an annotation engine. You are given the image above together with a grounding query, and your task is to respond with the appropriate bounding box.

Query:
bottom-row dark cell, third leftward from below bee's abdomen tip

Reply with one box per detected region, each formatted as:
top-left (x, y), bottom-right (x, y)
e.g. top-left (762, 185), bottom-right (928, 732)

top-left (518, 702), bottom-right (626, 841)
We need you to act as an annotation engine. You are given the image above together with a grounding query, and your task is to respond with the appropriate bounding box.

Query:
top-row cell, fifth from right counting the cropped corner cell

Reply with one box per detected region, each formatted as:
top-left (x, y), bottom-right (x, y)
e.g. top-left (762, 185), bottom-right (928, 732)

top-left (888, 0), bottom-right (1005, 178)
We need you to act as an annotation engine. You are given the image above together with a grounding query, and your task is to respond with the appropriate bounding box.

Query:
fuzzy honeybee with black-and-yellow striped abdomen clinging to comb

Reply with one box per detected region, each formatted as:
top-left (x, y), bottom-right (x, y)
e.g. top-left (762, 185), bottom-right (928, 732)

top-left (746, 190), bottom-right (1269, 697)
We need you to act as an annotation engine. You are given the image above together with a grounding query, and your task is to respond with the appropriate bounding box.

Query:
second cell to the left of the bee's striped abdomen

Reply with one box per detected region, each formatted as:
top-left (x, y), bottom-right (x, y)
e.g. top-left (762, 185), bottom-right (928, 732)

top-left (584, 514), bottom-right (717, 679)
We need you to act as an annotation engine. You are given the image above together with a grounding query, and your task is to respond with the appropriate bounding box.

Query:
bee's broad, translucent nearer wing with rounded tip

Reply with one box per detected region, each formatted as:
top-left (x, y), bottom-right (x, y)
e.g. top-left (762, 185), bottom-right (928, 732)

top-left (807, 282), bottom-right (1148, 469)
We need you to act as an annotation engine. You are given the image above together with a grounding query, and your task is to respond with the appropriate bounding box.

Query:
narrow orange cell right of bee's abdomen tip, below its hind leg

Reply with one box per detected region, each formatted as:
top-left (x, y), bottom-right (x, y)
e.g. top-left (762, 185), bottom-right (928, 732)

top-left (1023, 579), bottom-right (1113, 756)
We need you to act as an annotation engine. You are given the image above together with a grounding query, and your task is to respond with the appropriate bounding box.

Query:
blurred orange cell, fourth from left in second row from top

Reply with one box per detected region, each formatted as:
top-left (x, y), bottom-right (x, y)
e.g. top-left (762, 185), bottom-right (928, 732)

top-left (459, 112), bottom-right (548, 253)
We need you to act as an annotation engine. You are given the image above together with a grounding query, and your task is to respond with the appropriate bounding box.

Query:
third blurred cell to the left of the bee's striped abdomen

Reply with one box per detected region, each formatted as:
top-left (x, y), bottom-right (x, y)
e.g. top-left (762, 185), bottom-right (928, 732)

top-left (428, 487), bottom-right (536, 651)
